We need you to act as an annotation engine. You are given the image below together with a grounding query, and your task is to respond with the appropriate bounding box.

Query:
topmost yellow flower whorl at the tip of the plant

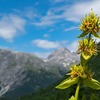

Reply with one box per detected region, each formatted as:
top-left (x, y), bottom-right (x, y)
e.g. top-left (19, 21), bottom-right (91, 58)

top-left (79, 11), bottom-right (100, 38)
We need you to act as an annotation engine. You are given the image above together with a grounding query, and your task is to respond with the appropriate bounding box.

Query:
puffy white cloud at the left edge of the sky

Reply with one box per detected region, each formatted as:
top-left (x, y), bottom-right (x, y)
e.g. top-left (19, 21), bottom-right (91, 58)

top-left (0, 14), bottom-right (25, 41)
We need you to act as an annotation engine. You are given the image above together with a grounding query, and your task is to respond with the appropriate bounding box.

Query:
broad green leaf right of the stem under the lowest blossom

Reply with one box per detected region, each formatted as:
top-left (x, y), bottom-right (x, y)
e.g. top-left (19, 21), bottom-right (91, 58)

top-left (83, 78), bottom-right (100, 90)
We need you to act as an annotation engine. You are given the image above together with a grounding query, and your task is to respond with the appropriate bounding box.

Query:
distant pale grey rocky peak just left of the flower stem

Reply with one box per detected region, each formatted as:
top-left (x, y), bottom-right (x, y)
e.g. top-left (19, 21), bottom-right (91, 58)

top-left (47, 48), bottom-right (79, 67)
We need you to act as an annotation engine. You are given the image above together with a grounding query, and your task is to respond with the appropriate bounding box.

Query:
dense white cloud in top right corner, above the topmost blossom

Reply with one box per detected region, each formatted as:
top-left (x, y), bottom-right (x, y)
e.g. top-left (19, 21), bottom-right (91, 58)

top-left (63, 0), bottom-right (100, 22)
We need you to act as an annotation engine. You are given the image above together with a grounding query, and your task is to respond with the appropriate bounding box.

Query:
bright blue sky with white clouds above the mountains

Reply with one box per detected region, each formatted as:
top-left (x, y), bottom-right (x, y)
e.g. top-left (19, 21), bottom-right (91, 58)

top-left (0, 0), bottom-right (100, 57)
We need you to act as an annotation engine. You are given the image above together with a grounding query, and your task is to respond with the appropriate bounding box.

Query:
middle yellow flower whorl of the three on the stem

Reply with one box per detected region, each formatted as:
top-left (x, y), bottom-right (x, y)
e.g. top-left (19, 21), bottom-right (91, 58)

top-left (78, 38), bottom-right (97, 59)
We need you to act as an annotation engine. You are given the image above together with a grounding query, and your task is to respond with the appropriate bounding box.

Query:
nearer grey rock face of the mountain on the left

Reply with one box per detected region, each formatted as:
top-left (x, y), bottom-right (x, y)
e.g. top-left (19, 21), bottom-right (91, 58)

top-left (0, 49), bottom-right (44, 95)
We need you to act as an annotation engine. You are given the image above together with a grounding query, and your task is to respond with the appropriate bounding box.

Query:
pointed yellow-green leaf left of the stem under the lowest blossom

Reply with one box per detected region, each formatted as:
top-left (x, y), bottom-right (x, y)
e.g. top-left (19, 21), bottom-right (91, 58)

top-left (56, 77), bottom-right (79, 89)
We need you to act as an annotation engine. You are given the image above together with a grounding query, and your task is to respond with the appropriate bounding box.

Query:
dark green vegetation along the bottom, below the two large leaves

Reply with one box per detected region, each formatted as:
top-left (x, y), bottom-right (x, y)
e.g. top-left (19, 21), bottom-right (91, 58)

top-left (18, 76), bottom-right (100, 100)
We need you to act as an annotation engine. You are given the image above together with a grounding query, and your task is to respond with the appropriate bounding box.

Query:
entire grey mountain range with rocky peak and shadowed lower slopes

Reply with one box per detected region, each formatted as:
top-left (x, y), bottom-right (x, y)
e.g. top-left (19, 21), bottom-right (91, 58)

top-left (0, 48), bottom-right (78, 100)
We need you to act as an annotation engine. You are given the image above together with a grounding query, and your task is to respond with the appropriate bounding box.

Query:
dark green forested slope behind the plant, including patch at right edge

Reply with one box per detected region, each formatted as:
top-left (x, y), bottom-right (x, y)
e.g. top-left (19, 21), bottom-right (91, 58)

top-left (15, 46), bottom-right (100, 100)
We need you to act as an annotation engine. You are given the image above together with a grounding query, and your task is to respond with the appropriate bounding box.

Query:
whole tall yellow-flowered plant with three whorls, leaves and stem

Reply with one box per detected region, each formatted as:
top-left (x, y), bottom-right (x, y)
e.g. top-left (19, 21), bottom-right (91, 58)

top-left (56, 11), bottom-right (100, 100)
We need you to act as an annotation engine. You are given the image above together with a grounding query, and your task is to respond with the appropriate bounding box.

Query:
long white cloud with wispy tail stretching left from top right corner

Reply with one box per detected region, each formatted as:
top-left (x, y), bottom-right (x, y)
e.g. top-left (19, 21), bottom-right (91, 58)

top-left (33, 0), bottom-right (100, 27)
